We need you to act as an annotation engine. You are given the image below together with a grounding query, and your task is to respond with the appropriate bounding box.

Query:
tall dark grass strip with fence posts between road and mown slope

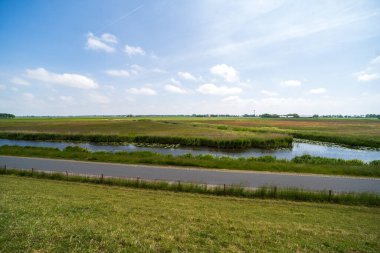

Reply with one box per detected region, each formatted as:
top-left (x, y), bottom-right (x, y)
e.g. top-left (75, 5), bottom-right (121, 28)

top-left (0, 167), bottom-right (380, 206)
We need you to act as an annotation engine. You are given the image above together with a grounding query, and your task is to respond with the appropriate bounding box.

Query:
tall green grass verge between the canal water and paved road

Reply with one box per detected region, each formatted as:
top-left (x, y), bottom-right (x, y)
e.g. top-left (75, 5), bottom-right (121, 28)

top-left (0, 146), bottom-right (380, 177)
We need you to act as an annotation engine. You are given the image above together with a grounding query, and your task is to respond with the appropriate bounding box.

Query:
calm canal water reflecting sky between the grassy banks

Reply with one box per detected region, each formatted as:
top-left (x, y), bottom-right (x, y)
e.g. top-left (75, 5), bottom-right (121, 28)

top-left (0, 139), bottom-right (380, 162)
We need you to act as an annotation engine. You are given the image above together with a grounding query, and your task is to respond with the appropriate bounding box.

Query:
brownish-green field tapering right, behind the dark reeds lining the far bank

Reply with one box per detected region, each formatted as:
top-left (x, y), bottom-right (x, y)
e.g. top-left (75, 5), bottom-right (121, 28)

top-left (0, 118), bottom-right (283, 140)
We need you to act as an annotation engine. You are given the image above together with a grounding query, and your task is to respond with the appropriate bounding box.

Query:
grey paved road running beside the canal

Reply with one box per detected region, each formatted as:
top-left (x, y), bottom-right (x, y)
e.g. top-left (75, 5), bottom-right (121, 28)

top-left (0, 156), bottom-right (380, 193)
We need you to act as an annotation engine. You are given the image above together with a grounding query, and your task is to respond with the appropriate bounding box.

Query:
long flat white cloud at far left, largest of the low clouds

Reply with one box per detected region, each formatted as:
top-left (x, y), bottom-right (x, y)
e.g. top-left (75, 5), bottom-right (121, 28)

top-left (26, 68), bottom-right (98, 89)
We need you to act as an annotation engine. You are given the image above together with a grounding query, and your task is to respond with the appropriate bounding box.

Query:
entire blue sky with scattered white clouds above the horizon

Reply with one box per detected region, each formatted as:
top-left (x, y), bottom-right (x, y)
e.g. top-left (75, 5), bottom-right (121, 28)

top-left (0, 0), bottom-right (380, 116)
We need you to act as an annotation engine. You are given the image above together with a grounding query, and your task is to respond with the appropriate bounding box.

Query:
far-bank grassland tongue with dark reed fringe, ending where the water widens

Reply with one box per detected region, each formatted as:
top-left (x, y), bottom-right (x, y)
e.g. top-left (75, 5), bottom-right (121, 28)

top-left (0, 119), bottom-right (292, 149)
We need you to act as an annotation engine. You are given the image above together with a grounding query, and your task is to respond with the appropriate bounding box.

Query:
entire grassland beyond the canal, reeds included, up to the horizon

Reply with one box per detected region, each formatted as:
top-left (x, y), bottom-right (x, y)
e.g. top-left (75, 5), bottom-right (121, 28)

top-left (0, 117), bottom-right (380, 149)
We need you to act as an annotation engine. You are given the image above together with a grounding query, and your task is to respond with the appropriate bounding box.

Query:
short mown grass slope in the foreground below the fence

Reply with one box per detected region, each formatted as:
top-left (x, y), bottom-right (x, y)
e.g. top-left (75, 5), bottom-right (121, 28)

top-left (0, 176), bottom-right (380, 252)
